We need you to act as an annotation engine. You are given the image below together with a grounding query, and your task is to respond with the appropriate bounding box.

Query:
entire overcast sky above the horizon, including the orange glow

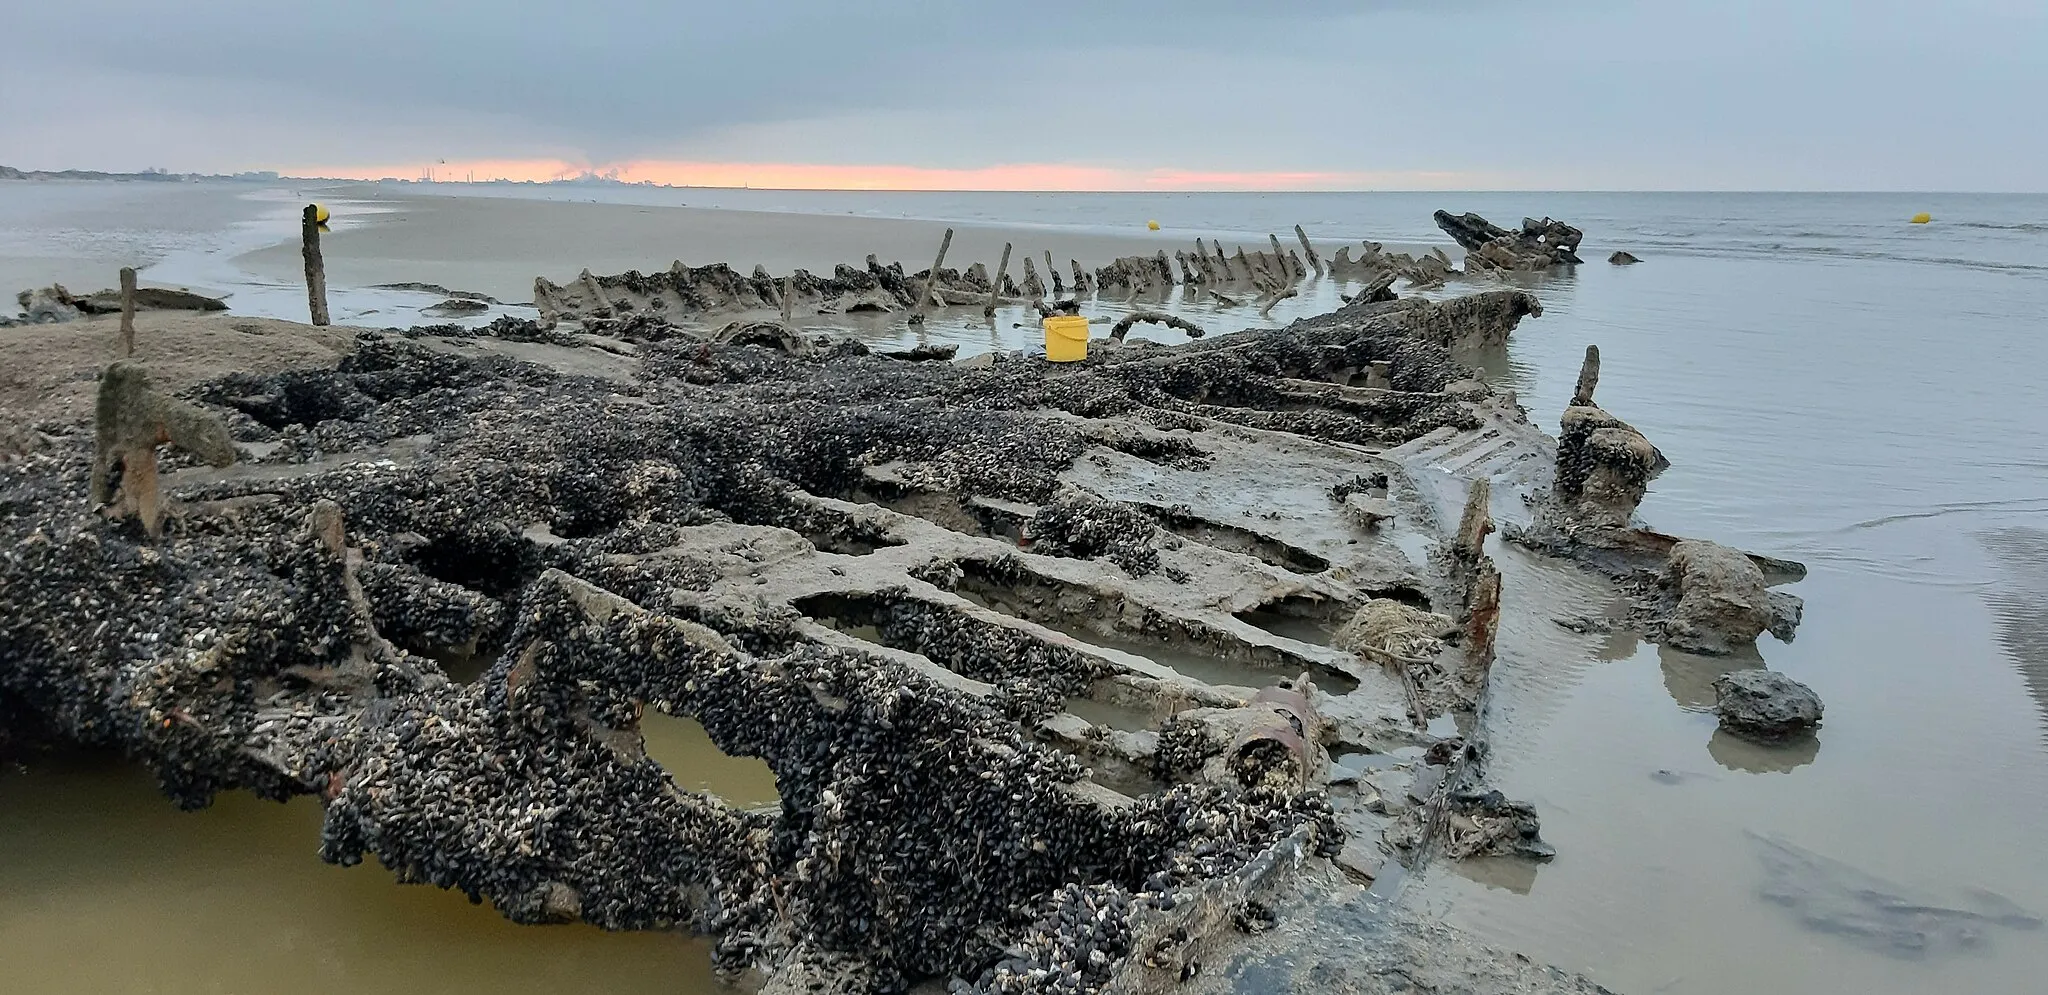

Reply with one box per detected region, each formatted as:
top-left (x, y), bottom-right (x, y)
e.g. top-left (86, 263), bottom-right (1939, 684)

top-left (0, 0), bottom-right (2048, 190)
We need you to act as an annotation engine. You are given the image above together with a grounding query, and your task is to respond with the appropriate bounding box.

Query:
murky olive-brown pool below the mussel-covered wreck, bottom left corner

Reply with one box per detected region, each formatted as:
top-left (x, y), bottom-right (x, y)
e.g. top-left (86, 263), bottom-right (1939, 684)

top-left (0, 758), bottom-right (733, 995)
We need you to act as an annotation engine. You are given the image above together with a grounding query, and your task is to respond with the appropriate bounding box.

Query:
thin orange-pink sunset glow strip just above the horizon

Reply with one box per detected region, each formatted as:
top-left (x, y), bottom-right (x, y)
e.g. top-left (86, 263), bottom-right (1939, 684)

top-left (285, 160), bottom-right (1481, 190)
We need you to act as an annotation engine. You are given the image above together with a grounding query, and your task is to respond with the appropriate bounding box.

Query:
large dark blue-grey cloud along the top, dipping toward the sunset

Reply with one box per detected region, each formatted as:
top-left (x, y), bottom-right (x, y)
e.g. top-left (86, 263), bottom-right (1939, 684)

top-left (23, 0), bottom-right (1425, 160)
